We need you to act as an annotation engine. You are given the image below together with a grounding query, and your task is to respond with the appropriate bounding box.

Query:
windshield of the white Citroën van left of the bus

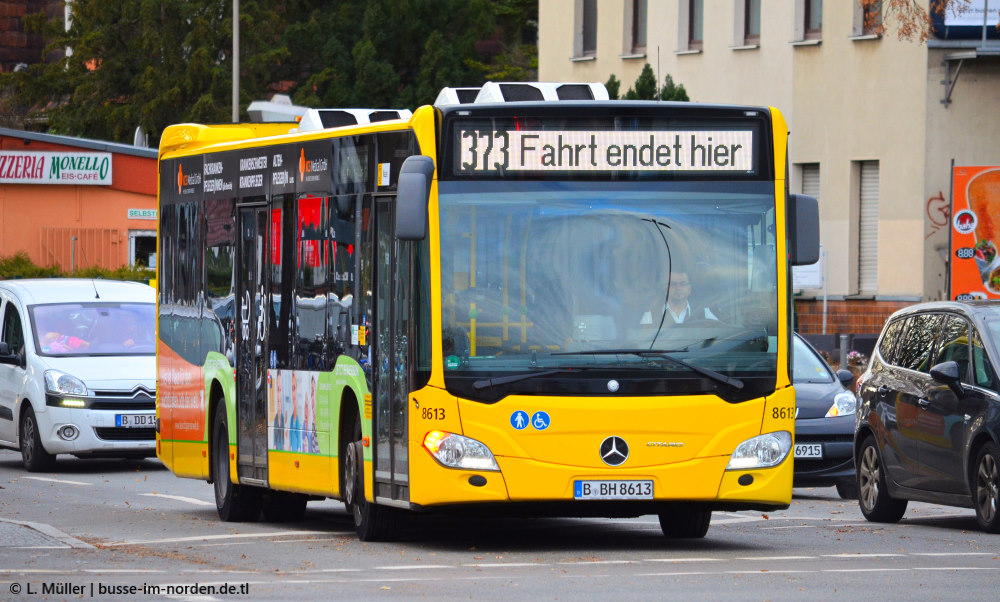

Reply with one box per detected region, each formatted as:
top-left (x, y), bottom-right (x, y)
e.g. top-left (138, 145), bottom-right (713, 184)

top-left (29, 302), bottom-right (156, 357)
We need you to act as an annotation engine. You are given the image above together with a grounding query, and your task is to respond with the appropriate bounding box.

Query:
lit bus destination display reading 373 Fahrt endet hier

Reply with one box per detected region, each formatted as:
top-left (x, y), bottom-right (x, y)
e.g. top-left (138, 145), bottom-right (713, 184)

top-left (455, 128), bottom-right (754, 175)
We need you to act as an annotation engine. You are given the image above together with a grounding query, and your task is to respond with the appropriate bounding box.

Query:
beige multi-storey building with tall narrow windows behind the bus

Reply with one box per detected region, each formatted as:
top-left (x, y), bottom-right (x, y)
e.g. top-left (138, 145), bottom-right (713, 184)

top-left (538, 0), bottom-right (1000, 334)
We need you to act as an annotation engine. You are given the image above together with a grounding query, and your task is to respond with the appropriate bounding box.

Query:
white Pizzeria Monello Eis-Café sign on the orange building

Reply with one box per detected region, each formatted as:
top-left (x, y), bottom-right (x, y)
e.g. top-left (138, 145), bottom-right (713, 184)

top-left (0, 151), bottom-right (111, 186)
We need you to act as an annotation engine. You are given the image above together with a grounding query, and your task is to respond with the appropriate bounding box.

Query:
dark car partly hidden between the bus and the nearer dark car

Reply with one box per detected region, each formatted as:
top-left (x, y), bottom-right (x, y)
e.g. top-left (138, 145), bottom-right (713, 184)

top-left (792, 333), bottom-right (857, 499)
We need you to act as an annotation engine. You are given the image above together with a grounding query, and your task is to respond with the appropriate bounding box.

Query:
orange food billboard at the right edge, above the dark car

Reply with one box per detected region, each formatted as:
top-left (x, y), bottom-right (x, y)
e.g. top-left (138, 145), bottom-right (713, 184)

top-left (951, 166), bottom-right (1000, 300)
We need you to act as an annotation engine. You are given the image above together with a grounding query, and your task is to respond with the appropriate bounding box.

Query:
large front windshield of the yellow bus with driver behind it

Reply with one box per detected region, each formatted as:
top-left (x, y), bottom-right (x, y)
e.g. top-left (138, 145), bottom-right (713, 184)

top-left (439, 181), bottom-right (778, 401)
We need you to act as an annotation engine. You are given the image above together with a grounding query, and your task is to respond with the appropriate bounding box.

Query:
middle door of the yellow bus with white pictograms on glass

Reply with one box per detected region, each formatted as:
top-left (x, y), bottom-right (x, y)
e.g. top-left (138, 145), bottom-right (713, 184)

top-left (236, 206), bottom-right (270, 485)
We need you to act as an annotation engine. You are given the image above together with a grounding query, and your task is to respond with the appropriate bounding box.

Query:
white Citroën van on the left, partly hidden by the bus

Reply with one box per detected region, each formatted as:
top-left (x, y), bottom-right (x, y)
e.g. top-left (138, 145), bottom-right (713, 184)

top-left (0, 278), bottom-right (156, 472)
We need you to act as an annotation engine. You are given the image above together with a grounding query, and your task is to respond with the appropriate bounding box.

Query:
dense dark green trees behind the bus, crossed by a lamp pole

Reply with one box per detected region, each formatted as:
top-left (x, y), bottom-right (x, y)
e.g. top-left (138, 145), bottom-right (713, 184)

top-left (0, 0), bottom-right (538, 143)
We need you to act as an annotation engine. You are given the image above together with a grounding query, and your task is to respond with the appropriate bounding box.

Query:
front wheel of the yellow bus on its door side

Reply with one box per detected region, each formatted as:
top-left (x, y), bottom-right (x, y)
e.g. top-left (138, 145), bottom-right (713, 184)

top-left (343, 418), bottom-right (399, 541)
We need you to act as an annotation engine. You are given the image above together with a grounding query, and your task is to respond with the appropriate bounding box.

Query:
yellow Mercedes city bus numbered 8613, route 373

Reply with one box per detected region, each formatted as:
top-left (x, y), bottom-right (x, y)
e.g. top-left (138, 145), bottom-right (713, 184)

top-left (156, 83), bottom-right (819, 540)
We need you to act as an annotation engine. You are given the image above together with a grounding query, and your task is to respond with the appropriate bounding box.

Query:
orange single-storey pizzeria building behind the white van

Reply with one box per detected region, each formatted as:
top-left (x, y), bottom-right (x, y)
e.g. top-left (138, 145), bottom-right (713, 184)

top-left (0, 128), bottom-right (157, 271)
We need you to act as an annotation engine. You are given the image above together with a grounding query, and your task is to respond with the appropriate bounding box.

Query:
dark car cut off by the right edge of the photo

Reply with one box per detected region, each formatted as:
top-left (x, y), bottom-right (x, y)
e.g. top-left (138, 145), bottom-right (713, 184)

top-left (854, 301), bottom-right (1000, 533)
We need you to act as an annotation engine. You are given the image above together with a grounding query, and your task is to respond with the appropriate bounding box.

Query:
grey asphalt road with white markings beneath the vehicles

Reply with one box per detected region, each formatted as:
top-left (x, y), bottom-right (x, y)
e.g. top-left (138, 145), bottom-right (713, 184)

top-left (0, 450), bottom-right (1000, 600)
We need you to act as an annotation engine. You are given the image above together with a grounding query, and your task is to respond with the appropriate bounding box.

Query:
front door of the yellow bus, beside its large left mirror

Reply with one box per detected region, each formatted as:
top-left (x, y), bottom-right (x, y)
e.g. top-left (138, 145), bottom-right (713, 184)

top-left (372, 197), bottom-right (413, 503)
